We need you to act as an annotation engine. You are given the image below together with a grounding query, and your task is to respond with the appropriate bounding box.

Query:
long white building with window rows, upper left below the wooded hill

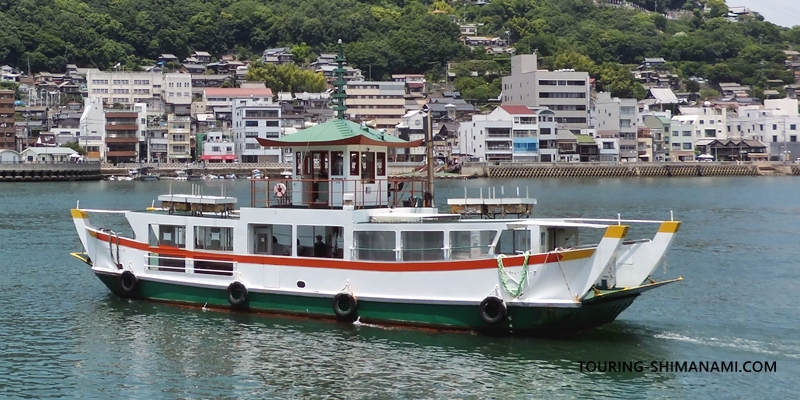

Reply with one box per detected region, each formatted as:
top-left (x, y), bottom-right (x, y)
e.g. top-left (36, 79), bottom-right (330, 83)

top-left (86, 69), bottom-right (192, 115)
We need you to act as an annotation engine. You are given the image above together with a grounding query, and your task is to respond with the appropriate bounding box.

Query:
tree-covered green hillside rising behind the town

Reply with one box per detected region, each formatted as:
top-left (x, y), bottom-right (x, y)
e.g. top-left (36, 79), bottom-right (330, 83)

top-left (0, 0), bottom-right (800, 90)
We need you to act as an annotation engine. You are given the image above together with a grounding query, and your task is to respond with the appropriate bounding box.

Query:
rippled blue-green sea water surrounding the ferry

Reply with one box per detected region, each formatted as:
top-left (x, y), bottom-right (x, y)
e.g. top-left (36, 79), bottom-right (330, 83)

top-left (0, 177), bottom-right (800, 399)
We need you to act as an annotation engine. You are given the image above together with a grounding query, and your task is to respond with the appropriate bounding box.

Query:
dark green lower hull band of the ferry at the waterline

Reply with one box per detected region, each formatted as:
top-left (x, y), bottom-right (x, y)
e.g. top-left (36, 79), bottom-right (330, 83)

top-left (97, 274), bottom-right (636, 334)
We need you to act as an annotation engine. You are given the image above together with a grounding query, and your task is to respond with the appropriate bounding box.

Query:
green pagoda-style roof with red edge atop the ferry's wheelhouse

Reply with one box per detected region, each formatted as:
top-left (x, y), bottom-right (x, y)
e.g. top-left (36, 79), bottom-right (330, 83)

top-left (258, 119), bottom-right (422, 147)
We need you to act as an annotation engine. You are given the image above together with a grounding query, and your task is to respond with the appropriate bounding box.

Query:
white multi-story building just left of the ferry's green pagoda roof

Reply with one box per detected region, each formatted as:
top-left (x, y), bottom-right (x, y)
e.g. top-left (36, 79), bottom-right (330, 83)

top-left (232, 99), bottom-right (285, 163)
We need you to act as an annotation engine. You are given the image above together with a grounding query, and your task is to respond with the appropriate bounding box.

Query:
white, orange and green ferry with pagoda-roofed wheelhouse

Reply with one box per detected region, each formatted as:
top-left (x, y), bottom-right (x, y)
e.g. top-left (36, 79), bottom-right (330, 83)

top-left (67, 45), bottom-right (681, 335)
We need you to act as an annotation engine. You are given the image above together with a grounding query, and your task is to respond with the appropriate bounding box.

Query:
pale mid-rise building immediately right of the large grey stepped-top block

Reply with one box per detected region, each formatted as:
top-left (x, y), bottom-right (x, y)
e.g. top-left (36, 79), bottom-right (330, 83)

top-left (594, 92), bottom-right (640, 162)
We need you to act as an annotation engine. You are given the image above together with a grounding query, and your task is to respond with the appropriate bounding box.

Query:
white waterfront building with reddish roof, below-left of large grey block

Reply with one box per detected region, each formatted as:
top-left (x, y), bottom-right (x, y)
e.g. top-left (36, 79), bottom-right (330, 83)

top-left (459, 105), bottom-right (558, 162)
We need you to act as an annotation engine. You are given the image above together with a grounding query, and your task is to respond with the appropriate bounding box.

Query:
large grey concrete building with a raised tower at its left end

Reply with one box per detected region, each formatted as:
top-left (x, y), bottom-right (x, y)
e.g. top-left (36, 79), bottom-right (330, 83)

top-left (501, 54), bottom-right (591, 133)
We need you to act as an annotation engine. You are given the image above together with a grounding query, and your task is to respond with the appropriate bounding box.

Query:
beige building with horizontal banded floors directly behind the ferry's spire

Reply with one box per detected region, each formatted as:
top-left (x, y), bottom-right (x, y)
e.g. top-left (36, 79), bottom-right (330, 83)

top-left (345, 81), bottom-right (406, 134)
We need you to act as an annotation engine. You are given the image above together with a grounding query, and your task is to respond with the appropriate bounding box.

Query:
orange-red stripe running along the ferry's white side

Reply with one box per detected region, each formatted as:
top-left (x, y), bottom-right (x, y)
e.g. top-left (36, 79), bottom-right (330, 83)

top-left (94, 230), bottom-right (594, 272)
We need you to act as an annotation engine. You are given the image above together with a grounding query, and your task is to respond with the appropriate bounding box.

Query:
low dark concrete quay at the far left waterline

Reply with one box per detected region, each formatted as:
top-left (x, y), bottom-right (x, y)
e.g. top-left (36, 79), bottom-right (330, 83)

top-left (0, 162), bottom-right (101, 182)
